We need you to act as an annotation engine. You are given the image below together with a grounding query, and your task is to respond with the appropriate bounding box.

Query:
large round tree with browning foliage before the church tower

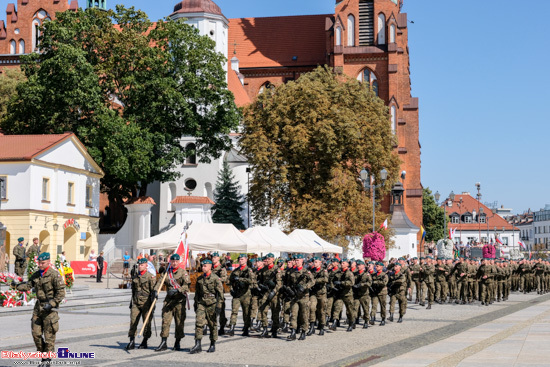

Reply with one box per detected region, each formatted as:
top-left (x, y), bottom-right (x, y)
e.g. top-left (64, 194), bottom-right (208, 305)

top-left (240, 67), bottom-right (400, 243)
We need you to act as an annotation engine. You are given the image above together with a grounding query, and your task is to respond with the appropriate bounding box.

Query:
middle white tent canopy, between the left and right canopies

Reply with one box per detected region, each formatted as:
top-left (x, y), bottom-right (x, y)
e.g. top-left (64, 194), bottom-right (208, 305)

top-left (244, 227), bottom-right (312, 253)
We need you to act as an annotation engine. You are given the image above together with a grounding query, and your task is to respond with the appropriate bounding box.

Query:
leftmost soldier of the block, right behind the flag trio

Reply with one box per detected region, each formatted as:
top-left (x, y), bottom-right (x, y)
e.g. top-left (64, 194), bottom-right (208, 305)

top-left (229, 254), bottom-right (256, 336)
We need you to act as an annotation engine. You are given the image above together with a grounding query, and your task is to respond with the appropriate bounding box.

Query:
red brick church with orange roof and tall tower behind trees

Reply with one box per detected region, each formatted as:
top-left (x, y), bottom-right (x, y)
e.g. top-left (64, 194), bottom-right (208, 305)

top-left (0, 0), bottom-right (422, 247)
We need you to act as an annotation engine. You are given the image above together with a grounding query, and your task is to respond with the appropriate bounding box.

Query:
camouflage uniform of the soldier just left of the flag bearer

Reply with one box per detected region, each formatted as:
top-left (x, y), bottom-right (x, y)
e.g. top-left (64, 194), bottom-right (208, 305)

top-left (128, 270), bottom-right (156, 339)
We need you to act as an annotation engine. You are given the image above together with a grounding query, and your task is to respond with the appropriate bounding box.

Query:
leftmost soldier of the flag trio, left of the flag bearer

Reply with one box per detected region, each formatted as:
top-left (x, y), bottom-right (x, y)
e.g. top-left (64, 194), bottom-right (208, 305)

top-left (126, 257), bottom-right (158, 350)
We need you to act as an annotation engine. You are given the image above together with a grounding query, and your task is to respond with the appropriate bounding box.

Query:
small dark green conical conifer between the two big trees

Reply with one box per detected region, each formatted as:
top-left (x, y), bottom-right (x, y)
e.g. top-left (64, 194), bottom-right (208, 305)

top-left (212, 161), bottom-right (245, 229)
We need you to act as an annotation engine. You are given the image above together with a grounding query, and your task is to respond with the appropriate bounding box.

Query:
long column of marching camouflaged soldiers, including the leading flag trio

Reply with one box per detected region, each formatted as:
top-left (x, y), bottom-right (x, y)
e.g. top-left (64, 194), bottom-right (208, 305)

top-left (121, 253), bottom-right (550, 354)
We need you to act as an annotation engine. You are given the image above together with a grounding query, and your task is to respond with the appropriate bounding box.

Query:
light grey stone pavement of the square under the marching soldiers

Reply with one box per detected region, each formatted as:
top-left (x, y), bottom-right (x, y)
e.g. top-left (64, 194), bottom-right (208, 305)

top-left (0, 289), bottom-right (550, 367)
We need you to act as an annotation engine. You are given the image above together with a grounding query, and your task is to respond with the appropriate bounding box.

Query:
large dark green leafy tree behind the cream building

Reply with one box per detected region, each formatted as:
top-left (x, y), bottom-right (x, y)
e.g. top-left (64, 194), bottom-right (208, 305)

top-left (2, 6), bottom-right (239, 204)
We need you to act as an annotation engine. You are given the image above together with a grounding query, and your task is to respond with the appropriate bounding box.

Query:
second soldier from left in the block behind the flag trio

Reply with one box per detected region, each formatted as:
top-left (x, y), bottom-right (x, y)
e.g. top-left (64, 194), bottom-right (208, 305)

top-left (257, 253), bottom-right (283, 338)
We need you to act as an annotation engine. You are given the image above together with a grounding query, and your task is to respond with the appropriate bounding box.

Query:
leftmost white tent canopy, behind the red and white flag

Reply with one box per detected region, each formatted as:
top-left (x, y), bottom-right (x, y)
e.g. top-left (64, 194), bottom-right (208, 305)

top-left (137, 223), bottom-right (258, 252)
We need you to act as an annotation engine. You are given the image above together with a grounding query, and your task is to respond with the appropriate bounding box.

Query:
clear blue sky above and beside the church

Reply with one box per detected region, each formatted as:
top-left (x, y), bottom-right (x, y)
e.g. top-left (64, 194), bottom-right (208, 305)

top-left (0, 0), bottom-right (550, 212)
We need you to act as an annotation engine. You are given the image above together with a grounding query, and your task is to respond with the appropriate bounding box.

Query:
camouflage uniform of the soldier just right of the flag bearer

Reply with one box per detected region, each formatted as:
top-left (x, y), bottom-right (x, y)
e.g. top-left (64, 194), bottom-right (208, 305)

top-left (194, 273), bottom-right (223, 342)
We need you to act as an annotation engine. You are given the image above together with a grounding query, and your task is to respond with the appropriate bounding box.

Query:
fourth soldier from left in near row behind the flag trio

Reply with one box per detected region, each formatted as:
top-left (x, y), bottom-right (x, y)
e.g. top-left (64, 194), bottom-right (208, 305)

top-left (307, 257), bottom-right (328, 336)
